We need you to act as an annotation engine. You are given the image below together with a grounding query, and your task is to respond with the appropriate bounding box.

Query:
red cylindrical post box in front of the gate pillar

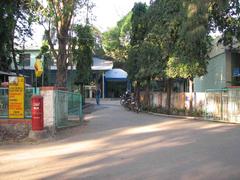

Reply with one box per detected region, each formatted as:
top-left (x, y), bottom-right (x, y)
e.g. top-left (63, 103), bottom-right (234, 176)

top-left (31, 96), bottom-right (43, 131)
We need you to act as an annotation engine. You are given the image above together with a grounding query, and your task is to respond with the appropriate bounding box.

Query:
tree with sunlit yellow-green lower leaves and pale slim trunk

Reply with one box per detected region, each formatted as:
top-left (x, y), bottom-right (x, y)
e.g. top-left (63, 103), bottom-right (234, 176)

top-left (166, 0), bottom-right (211, 111)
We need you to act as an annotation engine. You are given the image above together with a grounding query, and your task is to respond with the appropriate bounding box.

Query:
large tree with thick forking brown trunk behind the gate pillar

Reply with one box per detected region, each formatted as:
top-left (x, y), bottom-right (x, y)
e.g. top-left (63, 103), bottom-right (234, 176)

top-left (33, 0), bottom-right (89, 87)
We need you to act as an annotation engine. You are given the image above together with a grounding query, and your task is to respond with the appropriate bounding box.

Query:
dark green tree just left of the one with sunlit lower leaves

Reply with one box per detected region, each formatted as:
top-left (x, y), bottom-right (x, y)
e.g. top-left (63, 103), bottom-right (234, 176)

top-left (145, 0), bottom-right (182, 113)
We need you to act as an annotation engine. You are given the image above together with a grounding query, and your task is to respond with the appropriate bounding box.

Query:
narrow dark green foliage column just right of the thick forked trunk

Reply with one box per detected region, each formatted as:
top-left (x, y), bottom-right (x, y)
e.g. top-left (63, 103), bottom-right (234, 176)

top-left (72, 25), bottom-right (94, 85)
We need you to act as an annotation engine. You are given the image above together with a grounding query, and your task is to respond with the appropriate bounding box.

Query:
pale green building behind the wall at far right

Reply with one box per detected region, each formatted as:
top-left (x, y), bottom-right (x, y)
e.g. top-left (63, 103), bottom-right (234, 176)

top-left (194, 39), bottom-right (240, 92)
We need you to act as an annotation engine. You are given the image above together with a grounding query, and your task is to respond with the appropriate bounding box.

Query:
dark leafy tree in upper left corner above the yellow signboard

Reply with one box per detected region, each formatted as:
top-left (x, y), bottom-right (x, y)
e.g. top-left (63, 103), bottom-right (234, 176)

top-left (0, 0), bottom-right (32, 75)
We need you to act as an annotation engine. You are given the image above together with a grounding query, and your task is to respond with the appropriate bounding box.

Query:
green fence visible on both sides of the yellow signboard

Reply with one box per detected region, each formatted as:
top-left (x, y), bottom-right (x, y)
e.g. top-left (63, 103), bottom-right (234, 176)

top-left (0, 88), bottom-right (39, 118)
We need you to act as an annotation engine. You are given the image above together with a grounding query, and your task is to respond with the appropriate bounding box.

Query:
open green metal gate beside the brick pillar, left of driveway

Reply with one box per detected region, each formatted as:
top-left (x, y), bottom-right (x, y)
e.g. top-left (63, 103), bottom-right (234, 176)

top-left (54, 91), bottom-right (83, 128)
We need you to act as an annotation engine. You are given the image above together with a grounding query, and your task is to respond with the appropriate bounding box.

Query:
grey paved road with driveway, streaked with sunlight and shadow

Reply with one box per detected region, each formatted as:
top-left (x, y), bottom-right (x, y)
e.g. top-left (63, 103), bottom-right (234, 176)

top-left (0, 101), bottom-right (240, 180)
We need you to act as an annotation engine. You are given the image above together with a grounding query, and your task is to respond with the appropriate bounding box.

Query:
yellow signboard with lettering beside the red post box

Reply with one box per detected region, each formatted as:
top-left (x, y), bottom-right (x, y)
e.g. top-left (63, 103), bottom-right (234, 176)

top-left (8, 76), bottom-right (25, 119)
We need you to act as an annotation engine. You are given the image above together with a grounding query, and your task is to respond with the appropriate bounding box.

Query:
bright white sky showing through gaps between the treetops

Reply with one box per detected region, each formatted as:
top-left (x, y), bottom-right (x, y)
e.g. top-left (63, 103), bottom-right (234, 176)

top-left (26, 0), bottom-right (150, 47)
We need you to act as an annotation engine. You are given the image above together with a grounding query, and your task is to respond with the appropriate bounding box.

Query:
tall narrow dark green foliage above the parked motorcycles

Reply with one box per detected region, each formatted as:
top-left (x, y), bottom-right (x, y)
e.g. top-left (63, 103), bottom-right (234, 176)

top-left (127, 3), bottom-right (150, 81)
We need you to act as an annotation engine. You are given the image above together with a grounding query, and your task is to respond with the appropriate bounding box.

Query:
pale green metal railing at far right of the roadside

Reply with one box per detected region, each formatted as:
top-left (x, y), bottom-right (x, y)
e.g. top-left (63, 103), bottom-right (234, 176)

top-left (205, 88), bottom-right (240, 123)
